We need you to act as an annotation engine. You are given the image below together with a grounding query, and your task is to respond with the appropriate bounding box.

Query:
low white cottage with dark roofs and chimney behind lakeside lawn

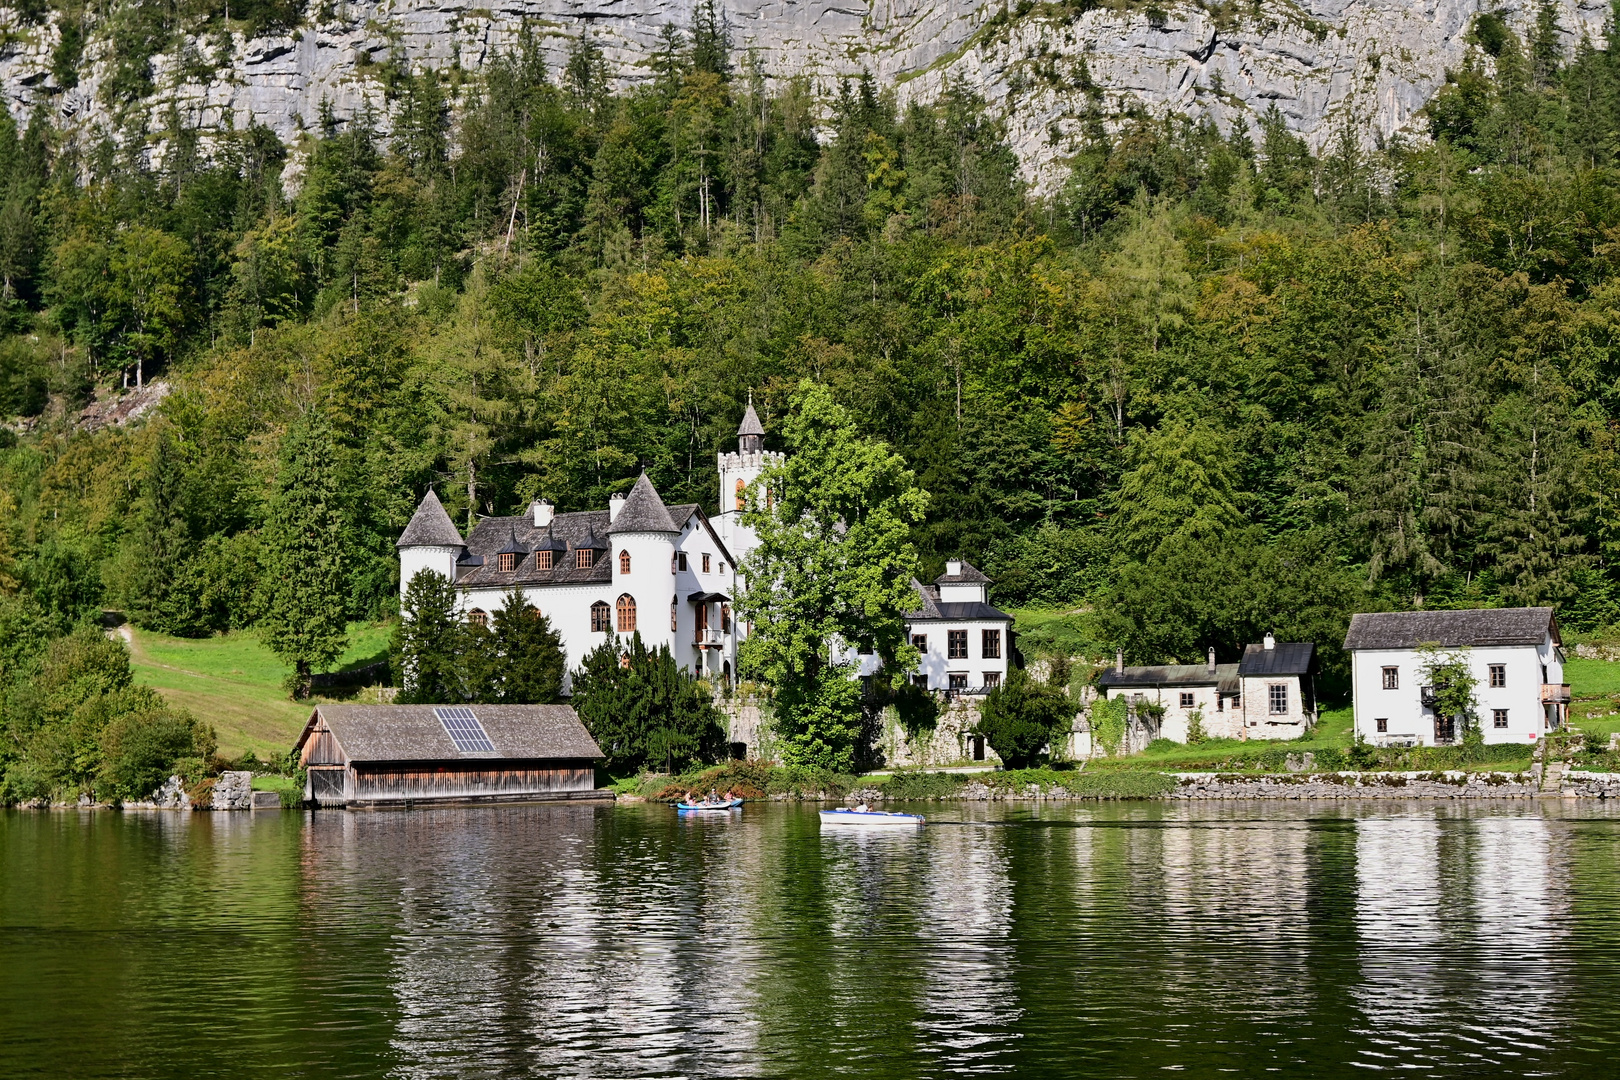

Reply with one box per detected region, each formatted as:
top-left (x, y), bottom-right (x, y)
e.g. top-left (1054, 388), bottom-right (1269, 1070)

top-left (1097, 635), bottom-right (1317, 743)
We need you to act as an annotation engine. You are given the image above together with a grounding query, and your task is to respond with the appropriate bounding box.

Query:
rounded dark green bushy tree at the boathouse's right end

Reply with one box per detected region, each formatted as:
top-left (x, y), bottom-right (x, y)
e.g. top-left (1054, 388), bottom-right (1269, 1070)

top-left (572, 633), bottom-right (726, 774)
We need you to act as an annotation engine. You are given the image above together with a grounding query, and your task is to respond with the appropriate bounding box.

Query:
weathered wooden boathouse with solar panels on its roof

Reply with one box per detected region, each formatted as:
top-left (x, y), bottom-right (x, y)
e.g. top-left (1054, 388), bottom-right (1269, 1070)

top-left (296, 704), bottom-right (603, 808)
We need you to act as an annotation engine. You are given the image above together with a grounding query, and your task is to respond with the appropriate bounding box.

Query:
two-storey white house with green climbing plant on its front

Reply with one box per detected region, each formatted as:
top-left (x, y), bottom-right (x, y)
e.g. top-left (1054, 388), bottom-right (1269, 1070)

top-left (1345, 607), bottom-right (1570, 746)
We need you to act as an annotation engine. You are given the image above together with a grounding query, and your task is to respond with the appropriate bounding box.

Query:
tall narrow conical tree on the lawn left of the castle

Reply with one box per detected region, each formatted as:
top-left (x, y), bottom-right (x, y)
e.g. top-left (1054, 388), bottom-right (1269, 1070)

top-left (259, 410), bottom-right (348, 698)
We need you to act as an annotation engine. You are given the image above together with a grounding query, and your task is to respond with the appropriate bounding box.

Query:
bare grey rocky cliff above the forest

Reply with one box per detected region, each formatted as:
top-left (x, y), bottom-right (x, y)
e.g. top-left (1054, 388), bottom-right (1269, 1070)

top-left (0, 0), bottom-right (1609, 188)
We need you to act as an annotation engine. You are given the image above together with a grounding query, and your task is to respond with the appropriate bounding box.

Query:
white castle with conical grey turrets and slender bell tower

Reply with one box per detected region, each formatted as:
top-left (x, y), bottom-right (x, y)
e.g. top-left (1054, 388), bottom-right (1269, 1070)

top-left (397, 403), bottom-right (781, 682)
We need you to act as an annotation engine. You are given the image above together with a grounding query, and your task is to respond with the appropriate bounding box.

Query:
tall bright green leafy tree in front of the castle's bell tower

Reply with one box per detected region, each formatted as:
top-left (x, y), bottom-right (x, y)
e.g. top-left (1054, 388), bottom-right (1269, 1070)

top-left (737, 379), bottom-right (928, 771)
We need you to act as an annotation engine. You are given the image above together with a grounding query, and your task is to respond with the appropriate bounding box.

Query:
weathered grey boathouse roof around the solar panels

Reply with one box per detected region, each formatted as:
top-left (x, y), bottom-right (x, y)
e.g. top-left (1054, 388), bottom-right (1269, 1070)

top-left (298, 704), bottom-right (603, 763)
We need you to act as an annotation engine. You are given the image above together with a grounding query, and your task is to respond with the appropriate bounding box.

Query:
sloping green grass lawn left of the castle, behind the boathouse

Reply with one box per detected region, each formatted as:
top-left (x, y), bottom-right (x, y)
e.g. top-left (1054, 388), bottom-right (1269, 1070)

top-left (118, 623), bottom-right (392, 758)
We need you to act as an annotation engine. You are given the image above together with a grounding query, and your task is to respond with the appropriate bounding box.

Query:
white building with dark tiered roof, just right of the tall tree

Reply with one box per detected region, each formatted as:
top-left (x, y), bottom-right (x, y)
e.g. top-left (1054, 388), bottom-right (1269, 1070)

top-left (844, 559), bottom-right (1013, 693)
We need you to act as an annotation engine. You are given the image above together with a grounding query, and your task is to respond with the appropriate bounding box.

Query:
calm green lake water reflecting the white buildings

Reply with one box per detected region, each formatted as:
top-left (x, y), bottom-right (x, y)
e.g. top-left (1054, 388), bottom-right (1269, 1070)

top-left (0, 803), bottom-right (1620, 1078)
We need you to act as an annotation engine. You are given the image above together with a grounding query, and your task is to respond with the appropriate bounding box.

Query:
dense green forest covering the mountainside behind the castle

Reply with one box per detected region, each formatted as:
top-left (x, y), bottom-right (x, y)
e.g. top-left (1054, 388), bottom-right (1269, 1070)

top-left (0, 5), bottom-right (1620, 777)
